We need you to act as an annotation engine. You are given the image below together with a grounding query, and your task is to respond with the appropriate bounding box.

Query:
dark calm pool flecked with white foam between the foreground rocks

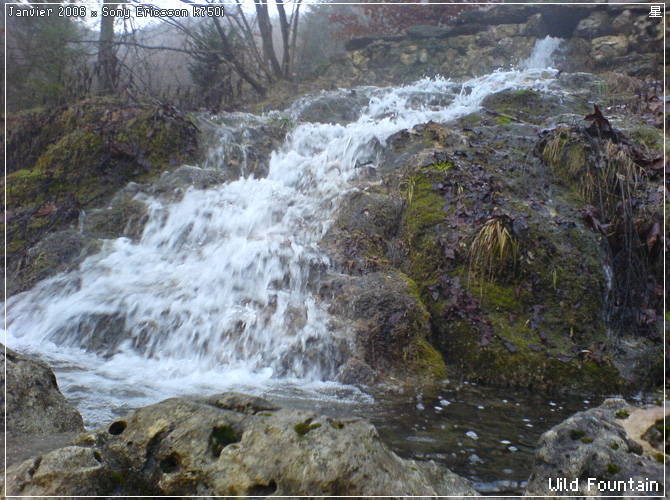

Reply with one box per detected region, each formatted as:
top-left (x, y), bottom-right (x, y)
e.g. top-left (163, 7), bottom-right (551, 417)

top-left (366, 382), bottom-right (604, 494)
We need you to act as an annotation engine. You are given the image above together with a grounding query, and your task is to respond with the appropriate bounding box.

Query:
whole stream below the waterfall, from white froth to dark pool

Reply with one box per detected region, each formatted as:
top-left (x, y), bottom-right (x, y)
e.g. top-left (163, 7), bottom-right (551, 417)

top-left (8, 334), bottom-right (620, 495)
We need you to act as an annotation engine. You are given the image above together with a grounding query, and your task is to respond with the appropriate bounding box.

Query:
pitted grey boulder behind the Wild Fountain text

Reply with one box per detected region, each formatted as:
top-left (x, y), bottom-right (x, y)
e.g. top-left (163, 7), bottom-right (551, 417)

top-left (524, 399), bottom-right (664, 496)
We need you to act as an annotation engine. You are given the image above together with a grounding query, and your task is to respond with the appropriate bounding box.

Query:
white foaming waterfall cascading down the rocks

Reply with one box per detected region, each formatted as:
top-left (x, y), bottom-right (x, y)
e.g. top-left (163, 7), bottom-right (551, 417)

top-left (6, 36), bottom-right (555, 424)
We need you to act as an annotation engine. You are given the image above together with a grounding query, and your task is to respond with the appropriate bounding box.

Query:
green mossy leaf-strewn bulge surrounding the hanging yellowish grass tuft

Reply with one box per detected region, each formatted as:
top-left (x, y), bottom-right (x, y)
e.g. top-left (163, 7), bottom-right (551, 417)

top-left (388, 124), bottom-right (636, 393)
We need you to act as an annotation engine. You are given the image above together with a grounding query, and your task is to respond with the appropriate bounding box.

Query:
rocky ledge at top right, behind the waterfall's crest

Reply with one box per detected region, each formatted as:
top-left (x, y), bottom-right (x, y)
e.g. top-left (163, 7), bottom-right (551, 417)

top-left (325, 4), bottom-right (663, 84)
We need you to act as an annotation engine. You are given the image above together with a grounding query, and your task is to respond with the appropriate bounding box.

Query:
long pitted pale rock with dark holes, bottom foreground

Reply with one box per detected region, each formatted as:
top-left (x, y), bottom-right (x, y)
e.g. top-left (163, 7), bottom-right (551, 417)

top-left (2, 394), bottom-right (476, 496)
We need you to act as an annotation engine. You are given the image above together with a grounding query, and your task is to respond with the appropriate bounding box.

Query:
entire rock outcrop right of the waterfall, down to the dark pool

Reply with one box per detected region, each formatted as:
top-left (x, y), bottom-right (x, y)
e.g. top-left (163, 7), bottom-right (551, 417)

top-left (319, 80), bottom-right (663, 393)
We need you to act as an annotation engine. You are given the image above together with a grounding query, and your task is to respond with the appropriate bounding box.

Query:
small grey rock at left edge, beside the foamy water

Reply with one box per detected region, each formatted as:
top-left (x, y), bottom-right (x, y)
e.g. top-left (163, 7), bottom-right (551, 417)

top-left (0, 344), bottom-right (84, 436)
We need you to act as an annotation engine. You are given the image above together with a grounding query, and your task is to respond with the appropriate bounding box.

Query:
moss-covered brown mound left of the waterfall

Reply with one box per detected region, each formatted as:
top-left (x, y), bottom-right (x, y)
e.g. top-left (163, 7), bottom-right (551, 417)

top-left (4, 98), bottom-right (197, 295)
